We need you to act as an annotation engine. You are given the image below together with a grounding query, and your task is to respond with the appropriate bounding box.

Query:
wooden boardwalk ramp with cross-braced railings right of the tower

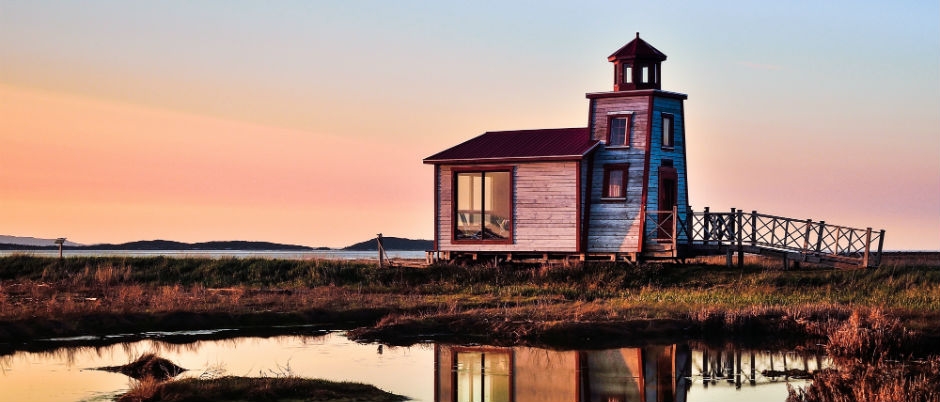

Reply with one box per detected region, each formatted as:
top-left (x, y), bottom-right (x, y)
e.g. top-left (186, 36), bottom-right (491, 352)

top-left (641, 208), bottom-right (885, 268)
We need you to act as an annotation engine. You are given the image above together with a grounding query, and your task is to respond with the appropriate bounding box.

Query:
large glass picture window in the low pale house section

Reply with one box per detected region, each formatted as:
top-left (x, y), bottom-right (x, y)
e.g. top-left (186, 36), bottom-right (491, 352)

top-left (454, 171), bottom-right (512, 241)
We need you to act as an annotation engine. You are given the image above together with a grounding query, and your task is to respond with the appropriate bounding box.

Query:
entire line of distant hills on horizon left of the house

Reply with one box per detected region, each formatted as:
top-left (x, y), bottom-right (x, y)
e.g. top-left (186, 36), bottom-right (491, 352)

top-left (0, 235), bottom-right (432, 251)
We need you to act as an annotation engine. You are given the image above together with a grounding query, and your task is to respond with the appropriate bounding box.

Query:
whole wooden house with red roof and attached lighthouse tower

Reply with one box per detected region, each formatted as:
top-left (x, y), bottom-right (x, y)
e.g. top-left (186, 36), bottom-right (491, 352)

top-left (424, 33), bottom-right (688, 260)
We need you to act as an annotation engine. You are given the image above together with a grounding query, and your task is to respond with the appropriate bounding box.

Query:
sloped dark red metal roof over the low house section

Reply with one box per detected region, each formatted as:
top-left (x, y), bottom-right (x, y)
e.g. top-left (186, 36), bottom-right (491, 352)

top-left (424, 127), bottom-right (598, 164)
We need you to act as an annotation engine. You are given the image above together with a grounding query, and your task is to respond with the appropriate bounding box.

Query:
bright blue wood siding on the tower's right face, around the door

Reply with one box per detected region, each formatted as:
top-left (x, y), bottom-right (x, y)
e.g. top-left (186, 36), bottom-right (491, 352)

top-left (646, 97), bottom-right (689, 240)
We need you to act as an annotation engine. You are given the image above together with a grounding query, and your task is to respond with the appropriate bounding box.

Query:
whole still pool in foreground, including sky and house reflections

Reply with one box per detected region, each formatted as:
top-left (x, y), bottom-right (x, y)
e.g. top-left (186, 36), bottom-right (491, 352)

top-left (0, 332), bottom-right (830, 402)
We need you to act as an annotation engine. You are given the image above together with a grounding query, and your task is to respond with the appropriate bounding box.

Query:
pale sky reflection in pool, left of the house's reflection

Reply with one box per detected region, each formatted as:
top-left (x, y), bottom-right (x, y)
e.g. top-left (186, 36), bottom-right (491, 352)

top-left (0, 334), bottom-right (434, 402)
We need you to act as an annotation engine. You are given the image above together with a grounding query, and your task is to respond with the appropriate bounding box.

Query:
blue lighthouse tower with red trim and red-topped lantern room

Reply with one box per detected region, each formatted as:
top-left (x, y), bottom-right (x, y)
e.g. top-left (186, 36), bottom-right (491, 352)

top-left (583, 33), bottom-right (689, 256)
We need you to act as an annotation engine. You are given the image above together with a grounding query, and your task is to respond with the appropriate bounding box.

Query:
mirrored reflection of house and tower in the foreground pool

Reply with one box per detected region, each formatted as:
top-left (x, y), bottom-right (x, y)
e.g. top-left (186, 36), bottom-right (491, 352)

top-left (434, 345), bottom-right (691, 402)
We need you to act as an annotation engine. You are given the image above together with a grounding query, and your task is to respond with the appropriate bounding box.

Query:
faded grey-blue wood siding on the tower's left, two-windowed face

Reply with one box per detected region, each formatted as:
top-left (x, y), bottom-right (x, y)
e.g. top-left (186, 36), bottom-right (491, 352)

top-left (586, 95), bottom-right (650, 253)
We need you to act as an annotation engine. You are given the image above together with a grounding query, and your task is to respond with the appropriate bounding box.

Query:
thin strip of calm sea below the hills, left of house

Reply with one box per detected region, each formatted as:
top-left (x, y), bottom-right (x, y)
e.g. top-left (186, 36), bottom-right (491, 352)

top-left (0, 250), bottom-right (424, 260)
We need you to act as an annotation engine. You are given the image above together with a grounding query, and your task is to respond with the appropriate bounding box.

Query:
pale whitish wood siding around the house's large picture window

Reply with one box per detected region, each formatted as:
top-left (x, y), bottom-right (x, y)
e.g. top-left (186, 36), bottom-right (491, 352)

top-left (437, 161), bottom-right (578, 252)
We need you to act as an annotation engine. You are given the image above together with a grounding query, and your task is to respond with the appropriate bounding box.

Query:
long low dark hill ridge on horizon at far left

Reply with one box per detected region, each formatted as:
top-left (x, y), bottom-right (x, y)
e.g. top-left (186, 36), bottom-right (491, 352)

top-left (0, 240), bottom-right (314, 251)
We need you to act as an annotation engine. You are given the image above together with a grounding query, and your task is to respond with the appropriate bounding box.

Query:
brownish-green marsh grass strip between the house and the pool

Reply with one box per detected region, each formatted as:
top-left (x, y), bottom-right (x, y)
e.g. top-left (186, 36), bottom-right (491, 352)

top-left (0, 254), bottom-right (940, 347)
